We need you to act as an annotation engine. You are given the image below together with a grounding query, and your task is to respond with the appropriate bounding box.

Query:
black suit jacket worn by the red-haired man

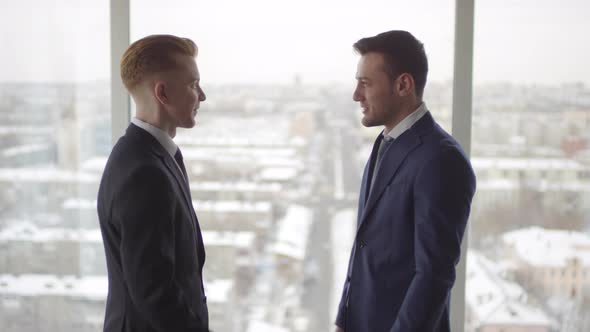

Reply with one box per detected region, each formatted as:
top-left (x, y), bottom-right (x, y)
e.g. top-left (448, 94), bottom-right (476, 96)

top-left (98, 124), bottom-right (209, 332)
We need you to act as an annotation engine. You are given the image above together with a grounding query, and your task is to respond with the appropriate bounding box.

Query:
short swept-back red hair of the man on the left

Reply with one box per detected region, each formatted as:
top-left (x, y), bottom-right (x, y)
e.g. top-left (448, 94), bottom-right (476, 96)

top-left (121, 35), bottom-right (198, 92)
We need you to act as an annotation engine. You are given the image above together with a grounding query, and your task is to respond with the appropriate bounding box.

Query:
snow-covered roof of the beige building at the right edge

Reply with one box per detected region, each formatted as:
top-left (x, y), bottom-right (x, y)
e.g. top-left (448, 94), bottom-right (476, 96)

top-left (502, 227), bottom-right (590, 267)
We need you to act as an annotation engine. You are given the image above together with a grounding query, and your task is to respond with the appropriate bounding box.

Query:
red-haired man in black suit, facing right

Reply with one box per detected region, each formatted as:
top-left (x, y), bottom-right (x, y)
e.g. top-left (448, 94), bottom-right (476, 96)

top-left (97, 35), bottom-right (209, 332)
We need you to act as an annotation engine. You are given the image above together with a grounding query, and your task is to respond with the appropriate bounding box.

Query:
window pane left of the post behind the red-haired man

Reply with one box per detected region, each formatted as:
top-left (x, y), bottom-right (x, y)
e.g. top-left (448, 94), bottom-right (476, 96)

top-left (0, 0), bottom-right (111, 332)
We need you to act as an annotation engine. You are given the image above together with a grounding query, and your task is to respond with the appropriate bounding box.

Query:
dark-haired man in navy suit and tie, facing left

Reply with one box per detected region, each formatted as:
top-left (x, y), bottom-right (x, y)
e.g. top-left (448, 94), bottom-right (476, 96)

top-left (336, 31), bottom-right (475, 332)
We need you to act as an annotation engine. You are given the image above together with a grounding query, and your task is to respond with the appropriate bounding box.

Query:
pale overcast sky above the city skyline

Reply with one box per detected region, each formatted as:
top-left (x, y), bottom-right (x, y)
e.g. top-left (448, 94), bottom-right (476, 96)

top-left (0, 0), bottom-right (590, 85)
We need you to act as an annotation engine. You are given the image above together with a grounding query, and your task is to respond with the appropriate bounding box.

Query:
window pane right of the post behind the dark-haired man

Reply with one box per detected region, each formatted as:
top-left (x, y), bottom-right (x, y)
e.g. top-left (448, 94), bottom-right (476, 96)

top-left (466, 0), bottom-right (590, 331)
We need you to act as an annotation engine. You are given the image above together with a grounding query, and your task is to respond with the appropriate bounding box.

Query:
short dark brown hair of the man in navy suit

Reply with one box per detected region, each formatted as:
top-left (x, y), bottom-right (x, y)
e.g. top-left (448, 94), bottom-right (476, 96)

top-left (353, 30), bottom-right (428, 98)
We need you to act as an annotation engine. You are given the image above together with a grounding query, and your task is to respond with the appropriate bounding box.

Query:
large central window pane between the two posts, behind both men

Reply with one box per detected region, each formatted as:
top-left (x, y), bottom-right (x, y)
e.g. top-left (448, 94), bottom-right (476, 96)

top-left (131, 0), bottom-right (454, 332)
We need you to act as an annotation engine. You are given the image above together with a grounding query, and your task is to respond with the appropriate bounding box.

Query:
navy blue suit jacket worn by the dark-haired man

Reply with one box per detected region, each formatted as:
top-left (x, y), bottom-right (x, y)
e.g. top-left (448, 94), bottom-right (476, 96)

top-left (336, 113), bottom-right (475, 332)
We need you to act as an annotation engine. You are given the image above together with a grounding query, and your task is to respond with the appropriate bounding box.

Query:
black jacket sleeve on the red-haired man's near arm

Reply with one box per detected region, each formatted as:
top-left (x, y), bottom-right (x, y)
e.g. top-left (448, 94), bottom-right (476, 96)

top-left (112, 166), bottom-right (207, 332)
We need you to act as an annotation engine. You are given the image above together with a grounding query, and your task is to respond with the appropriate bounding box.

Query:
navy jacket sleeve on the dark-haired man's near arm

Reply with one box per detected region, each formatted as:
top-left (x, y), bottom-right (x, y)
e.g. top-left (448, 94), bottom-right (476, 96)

top-left (390, 147), bottom-right (475, 332)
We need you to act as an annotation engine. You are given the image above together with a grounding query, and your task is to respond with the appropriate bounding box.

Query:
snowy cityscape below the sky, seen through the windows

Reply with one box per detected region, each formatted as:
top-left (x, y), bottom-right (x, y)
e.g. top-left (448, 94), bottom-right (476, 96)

top-left (0, 77), bottom-right (590, 332)
